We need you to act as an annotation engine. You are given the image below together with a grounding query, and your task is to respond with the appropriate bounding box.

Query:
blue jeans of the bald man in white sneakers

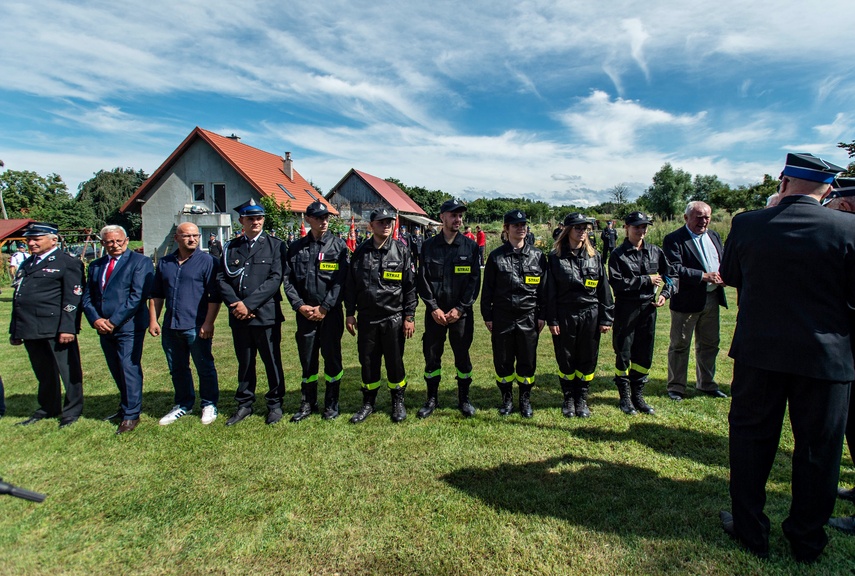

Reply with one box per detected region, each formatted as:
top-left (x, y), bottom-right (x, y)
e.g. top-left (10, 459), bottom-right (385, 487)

top-left (161, 327), bottom-right (220, 411)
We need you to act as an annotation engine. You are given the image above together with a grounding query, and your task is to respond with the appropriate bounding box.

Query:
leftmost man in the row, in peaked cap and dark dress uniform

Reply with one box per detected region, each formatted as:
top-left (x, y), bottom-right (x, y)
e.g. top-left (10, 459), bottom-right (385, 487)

top-left (9, 222), bottom-right (83, 428)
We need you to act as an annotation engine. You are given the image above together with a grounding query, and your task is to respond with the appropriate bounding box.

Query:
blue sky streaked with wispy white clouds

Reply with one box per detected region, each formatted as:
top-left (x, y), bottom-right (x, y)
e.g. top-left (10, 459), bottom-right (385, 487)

top-left (0, 0), bottom-right (855, 205)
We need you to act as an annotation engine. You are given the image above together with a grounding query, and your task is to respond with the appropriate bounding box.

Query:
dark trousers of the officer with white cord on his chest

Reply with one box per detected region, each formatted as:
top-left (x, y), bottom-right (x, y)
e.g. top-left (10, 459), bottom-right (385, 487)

top-left (232, 322), bottom-right (285, 410)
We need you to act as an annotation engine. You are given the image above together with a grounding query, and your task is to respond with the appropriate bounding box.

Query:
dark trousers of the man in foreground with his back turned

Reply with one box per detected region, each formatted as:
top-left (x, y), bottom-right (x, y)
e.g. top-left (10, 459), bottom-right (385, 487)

top-left (728, 361), bottom-right (849, 558)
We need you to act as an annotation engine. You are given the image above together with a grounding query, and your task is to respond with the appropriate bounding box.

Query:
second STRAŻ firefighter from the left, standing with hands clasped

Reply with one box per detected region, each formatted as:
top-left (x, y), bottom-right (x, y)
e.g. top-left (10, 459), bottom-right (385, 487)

top-left (344, 208), bottom-right (418, 424)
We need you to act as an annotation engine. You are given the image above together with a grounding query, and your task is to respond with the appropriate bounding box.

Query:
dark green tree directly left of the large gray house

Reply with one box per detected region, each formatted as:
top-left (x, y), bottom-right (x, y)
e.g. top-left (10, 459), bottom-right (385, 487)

top-left (77, 168), bottom-right (148, 238)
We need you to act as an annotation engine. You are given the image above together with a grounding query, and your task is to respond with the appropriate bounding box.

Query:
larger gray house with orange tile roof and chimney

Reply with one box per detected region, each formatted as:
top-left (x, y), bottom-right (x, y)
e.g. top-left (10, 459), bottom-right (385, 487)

top-left (121, 126), bottom-right (338, 258)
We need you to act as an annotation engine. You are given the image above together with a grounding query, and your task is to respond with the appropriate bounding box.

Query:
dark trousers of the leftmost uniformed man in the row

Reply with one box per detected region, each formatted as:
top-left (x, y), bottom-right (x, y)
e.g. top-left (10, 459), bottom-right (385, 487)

top-left (24, 338), bottom-right (83, 418)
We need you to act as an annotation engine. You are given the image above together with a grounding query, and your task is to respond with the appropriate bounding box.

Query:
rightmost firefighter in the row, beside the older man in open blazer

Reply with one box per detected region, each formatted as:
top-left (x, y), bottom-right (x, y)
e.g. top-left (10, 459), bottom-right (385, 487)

top-left (609, 212), bottom-right (677, 414)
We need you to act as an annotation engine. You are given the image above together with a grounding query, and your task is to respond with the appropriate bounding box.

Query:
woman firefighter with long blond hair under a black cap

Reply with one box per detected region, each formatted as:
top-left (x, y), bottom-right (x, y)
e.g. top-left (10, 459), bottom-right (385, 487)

top-left (546, 212), bottom-right (614, 418)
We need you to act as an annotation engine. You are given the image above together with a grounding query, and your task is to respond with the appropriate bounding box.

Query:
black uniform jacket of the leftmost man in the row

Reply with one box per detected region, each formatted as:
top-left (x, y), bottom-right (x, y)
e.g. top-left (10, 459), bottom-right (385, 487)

top-left (9, 249), bottom-right (83, 340)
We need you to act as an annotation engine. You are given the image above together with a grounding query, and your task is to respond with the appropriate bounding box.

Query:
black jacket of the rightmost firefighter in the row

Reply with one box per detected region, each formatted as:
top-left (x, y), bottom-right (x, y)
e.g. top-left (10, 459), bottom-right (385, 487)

top-left (609, 240), bottom-right (677, 303)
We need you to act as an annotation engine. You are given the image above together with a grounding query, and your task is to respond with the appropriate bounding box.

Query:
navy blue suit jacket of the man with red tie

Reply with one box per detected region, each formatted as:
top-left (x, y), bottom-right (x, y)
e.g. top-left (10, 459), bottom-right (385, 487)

top-left (83, 250), bottom-right (154, 333)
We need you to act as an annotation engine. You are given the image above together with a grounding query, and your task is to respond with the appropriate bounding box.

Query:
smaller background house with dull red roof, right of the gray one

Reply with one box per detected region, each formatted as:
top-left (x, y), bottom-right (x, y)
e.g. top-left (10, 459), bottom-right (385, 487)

top-left (326, 168), bottom-right (441, 229)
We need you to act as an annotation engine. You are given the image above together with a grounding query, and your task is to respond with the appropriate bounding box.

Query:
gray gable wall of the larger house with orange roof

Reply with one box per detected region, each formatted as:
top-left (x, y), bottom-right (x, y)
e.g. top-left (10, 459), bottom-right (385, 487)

top-left (142, 139), bottom-right (261, 258)
